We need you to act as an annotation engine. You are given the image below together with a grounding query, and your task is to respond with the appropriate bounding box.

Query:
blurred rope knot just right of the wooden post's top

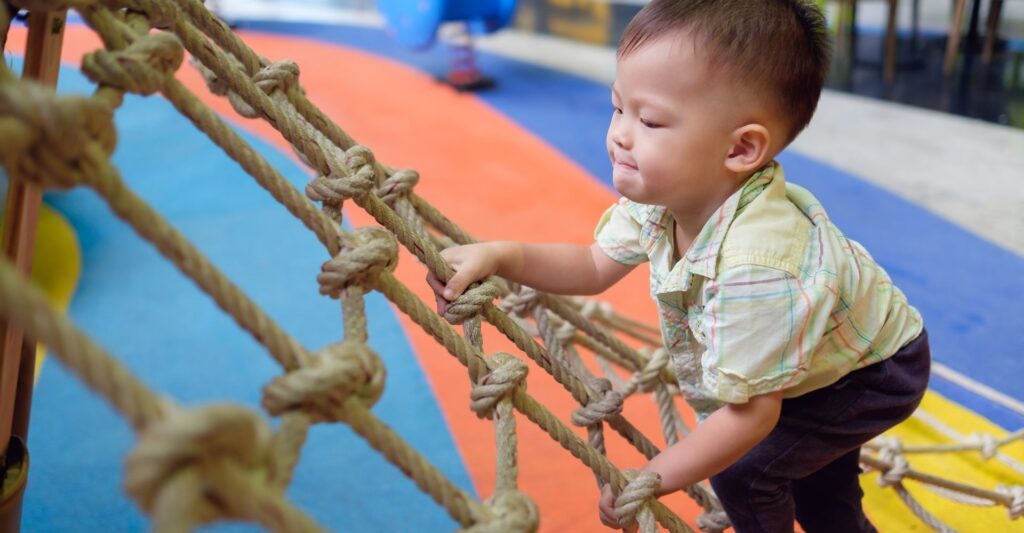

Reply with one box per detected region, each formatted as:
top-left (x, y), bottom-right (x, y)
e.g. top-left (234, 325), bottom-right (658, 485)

top-left (82, 32), bottom-right (184, 95)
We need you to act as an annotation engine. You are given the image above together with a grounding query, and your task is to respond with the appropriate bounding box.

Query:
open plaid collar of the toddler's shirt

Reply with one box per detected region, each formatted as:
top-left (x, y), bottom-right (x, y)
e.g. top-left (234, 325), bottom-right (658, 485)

top-left (647, 161), bottom-right (783, 294)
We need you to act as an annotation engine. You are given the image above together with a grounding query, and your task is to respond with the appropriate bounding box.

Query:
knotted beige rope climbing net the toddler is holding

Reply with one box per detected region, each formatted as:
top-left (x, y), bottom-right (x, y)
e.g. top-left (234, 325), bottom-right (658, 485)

top-left (0, 0), bottom-right (1024, 532)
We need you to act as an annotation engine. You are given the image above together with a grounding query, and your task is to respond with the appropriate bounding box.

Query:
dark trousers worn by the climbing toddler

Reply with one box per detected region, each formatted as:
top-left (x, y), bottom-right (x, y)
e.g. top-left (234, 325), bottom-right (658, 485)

top-left (711, 331), bottom-right (931, 533)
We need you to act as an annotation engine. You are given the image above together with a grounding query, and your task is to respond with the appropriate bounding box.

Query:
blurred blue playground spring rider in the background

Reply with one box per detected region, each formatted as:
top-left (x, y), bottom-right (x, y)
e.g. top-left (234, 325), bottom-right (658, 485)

top-left (378, 0), bottom-right (516, 91)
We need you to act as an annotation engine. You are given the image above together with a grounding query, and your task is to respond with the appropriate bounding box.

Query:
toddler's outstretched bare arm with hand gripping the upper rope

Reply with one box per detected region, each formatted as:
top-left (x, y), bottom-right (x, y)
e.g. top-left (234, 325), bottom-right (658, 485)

top-left (427, 240), bottom-right (634, 311)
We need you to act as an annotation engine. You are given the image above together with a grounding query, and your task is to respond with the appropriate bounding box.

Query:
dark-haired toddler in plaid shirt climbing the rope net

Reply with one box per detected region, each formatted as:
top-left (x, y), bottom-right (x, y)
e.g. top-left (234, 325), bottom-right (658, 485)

top-left (428, 0), bottom-right (930, 533)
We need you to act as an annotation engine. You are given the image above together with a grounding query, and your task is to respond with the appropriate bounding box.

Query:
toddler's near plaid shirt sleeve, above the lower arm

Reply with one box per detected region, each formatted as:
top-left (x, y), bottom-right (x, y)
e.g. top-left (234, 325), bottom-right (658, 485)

top-left (700, 265), bottom-right (838, 403)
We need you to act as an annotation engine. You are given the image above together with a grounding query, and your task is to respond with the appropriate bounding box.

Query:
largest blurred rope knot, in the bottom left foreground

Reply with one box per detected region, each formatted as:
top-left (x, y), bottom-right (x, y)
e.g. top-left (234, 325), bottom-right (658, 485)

top-left (125, 405), bottom-right (273, 523)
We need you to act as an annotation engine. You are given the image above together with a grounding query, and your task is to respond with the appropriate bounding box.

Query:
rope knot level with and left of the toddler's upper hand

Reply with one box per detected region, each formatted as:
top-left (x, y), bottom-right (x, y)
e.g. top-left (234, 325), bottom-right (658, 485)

top-left (316, 227), bottom-right (398, 298)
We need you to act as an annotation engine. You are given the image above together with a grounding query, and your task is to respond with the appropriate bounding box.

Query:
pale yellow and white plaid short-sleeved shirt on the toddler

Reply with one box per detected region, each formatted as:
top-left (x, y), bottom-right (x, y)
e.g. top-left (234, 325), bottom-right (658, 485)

top-left (595, 162), bottom-right (923, 419)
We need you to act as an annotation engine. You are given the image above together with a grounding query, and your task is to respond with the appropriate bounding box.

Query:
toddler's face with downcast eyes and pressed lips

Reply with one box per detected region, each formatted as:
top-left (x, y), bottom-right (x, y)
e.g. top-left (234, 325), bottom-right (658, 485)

top-left (606, 36), bottom-right (743, 212)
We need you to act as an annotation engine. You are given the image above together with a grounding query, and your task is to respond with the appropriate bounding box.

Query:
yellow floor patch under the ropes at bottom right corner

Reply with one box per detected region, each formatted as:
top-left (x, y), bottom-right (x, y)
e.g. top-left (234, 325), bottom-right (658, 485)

top-left (861, 391), bottom-right (1024, 533)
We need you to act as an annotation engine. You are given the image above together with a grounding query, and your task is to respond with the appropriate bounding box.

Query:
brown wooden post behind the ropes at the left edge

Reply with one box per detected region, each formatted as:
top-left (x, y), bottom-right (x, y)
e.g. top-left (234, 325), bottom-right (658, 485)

top-left (0, 0), bottom-right (67, 501)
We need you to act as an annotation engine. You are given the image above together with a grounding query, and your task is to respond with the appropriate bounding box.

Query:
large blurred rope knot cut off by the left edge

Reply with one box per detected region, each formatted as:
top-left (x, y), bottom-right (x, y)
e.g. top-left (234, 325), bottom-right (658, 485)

top-left (0, 82), bottom-right (117, 188)
